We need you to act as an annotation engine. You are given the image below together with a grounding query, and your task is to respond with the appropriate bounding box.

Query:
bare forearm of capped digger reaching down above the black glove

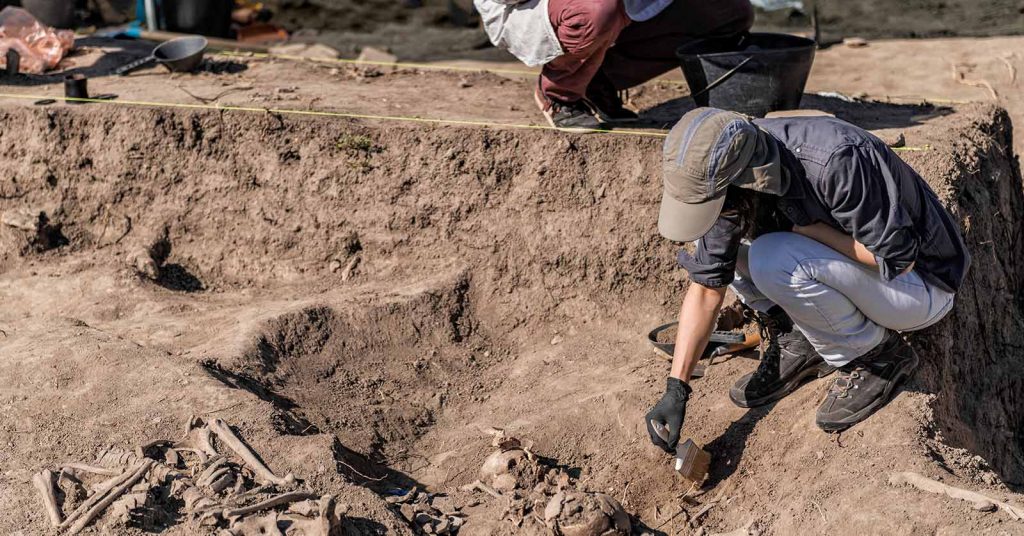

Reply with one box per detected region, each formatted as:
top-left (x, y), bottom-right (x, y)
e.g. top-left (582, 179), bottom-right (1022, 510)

top-left (671, 283), bottom-right (725, 382)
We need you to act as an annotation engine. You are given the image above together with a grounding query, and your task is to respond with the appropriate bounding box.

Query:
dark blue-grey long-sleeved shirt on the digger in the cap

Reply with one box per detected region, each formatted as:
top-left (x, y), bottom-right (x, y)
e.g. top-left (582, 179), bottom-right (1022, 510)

top-left (679, 117), bottom-right (971, 292)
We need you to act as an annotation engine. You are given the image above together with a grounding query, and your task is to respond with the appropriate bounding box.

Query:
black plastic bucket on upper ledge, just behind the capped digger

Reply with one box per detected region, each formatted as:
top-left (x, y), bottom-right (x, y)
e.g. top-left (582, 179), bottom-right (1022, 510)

top-left (676, 33), bottom-right (817, 117)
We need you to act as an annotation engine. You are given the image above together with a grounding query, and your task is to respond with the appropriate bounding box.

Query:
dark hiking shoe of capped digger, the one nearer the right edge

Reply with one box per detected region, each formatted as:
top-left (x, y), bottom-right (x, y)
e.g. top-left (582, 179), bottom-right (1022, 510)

top-left (815, 331), bottom-right (918, 431)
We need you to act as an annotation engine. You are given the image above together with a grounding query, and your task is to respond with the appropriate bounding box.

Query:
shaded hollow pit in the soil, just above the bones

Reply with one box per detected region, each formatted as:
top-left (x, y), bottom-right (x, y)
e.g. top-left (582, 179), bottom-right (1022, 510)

top-left (204, 272), bottom-right (487, 464)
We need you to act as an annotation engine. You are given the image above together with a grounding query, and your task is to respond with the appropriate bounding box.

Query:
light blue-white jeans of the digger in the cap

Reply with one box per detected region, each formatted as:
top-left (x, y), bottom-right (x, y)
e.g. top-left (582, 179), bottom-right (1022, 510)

top-left (732, 233), bottom-right (954, 367)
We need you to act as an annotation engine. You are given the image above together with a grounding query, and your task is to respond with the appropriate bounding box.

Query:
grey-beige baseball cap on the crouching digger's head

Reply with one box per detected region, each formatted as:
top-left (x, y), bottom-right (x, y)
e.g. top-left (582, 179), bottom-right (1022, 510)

top-left (657, 108), bottom-right (787, 242)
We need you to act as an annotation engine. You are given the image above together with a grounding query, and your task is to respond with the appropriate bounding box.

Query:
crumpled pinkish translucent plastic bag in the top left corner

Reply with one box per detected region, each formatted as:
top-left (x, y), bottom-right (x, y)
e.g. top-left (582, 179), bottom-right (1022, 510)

top-left (0, 7), bottom-right (75, 75)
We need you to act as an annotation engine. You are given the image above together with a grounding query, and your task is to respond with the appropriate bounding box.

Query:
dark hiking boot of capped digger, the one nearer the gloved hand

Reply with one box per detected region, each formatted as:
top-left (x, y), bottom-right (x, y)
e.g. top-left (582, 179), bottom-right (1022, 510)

top-left (729, 305), bottom-right (836, 408)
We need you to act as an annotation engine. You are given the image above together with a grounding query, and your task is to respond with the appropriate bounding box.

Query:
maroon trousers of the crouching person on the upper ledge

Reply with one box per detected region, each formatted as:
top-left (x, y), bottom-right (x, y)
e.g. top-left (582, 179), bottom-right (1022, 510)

top-left (541, 0), bottom-right (754, 101)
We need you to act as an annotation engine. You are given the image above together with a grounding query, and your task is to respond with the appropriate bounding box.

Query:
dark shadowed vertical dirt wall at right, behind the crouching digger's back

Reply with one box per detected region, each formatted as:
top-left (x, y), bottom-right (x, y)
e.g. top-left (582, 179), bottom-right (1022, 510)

top-left (908, 111), bottom-right (1024, 485)
